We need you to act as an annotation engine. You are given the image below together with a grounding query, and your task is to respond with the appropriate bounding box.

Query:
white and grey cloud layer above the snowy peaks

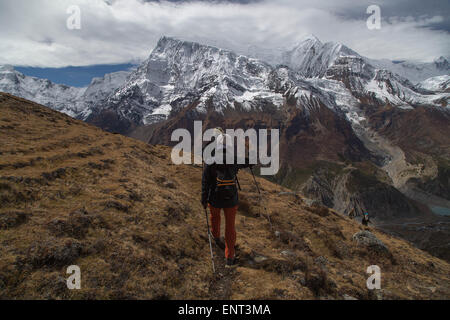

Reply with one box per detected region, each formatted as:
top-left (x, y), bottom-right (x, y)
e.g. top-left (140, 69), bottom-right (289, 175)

top-left (0, 0), bottom-right (450, 67)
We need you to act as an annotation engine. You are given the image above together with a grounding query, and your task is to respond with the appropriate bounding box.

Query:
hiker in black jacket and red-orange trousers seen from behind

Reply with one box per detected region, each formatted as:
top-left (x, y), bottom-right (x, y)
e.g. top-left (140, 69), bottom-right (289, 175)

top-left (202, 133), bottom-right (252, 268)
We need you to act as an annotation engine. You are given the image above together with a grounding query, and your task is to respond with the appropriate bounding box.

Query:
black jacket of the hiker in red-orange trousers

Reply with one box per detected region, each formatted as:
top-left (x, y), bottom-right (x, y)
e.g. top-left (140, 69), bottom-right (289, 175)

top-left (202, 153), bottom-right (252, 208)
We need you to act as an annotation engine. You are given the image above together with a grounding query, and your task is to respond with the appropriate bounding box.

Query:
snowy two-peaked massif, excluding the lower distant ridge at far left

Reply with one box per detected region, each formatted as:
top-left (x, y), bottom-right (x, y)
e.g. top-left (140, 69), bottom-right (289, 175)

top-left (82, 37), bottom-right (449, 134)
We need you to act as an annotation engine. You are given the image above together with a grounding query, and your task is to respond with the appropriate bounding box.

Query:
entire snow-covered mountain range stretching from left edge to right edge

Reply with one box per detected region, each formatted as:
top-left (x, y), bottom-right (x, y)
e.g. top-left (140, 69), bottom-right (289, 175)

top-left (0, 36), bottom-right (449, 126)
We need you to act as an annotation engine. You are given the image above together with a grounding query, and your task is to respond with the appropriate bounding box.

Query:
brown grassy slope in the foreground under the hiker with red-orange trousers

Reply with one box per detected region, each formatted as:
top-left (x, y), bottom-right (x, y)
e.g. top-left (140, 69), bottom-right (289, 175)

top-left (0, 94), bottom-right (450, 299)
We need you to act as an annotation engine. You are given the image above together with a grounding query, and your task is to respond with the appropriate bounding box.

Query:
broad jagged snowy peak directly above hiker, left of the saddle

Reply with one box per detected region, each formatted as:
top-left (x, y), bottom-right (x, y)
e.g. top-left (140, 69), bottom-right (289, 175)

top-left (96, 37), bottom-right (283, 124)
